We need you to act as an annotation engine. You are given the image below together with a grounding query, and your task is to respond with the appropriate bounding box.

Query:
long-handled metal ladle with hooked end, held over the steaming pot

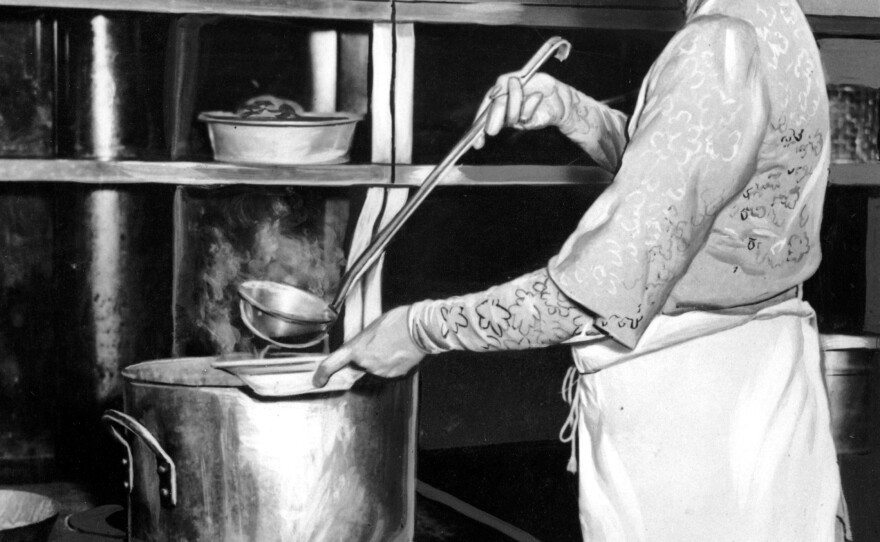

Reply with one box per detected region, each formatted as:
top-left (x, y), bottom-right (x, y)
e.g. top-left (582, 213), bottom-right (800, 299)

top-left (238, 36), bottom-right (571, 348)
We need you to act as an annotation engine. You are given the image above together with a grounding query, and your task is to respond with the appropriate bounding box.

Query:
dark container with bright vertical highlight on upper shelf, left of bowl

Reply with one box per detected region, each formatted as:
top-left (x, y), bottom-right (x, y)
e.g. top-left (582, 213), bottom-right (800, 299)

top-left (58, 12), bottom-right (168, 160)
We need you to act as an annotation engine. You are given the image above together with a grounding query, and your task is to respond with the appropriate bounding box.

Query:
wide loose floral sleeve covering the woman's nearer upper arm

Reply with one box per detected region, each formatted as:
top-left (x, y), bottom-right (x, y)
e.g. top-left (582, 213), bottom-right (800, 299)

top-left (549, 16), bottom-right (769, 347)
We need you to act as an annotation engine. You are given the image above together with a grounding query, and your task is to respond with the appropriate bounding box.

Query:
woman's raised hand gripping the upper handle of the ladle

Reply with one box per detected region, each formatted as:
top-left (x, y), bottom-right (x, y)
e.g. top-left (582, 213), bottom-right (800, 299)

top-left (473, 72), bottom-right (571, 149)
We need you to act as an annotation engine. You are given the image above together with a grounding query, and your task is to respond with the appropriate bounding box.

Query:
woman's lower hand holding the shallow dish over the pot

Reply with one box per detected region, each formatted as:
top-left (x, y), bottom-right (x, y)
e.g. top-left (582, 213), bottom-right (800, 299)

top-left (312, 307), bottom-right (425, 388)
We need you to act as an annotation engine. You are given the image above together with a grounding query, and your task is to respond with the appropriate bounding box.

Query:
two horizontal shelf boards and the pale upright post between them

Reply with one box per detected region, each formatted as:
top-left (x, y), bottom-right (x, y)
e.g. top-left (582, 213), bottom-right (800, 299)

top-left (0, 0), bottom-right (880, 190)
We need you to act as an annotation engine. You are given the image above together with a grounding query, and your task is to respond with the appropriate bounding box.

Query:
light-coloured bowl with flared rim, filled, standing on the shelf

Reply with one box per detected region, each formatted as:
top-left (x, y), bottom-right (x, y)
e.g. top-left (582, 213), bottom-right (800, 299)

top-left (199, 111), bottom-right (362, 165)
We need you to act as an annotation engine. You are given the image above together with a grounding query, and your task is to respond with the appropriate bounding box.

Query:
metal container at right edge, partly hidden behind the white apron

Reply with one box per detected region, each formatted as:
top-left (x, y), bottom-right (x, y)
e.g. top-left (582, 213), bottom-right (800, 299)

top-left (821, 335), bottom-right (880, 454)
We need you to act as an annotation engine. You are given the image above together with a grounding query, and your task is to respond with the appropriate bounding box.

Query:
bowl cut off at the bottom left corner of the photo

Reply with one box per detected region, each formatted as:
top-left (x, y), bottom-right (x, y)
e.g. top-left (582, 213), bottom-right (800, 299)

top-left (0, 489), bottom-right (58, 542)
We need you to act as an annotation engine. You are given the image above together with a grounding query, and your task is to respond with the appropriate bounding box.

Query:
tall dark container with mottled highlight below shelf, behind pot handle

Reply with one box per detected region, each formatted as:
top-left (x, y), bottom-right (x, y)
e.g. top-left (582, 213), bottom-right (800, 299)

top-left (53, 185), bottom-right (174, 488)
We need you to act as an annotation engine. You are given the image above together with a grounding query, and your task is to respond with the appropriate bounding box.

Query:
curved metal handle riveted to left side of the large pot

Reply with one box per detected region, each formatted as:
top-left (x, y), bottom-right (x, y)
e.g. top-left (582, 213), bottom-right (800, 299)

top-left (101, 409), bottom-right (177, 508)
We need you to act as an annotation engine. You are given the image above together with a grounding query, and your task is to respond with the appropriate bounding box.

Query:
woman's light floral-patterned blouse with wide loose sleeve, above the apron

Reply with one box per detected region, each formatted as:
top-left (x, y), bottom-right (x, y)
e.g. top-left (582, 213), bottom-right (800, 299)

top-left (548, 0), bottom-right (830, 347)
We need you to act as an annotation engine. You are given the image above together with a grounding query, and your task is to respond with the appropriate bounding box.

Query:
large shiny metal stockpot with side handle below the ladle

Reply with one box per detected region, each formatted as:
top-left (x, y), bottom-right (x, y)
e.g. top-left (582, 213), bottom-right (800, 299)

top-left (104, 358), bottom-right (416, 542)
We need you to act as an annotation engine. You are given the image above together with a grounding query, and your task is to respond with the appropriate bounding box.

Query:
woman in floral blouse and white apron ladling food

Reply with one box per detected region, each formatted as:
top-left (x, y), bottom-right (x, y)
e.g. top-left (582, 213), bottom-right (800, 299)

top-left (315, 0), bottom-right (843, 542)
